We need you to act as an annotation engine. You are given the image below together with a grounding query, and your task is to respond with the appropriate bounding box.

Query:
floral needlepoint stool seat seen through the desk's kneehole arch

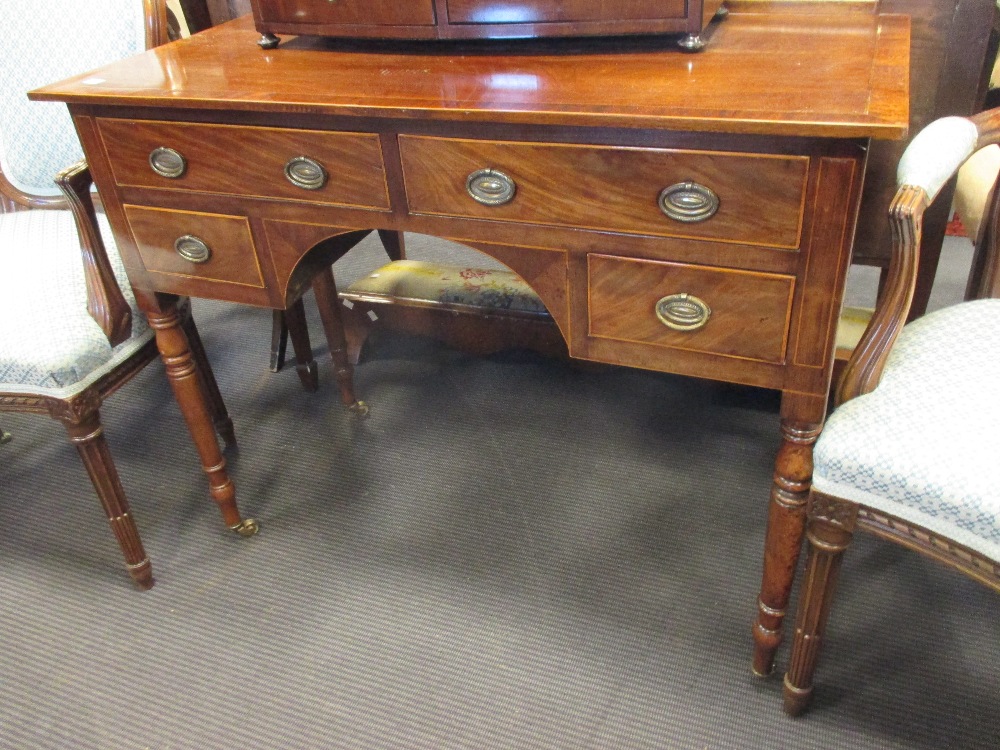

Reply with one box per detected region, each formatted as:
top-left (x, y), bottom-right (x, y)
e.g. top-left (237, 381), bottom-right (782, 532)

top-left (345, 260), bottom-right (548, 315)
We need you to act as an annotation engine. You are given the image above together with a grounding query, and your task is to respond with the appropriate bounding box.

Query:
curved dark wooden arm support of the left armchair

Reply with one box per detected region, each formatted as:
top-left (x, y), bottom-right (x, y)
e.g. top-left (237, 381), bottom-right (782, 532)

top-left (56, 161), bottom-right (132, 346)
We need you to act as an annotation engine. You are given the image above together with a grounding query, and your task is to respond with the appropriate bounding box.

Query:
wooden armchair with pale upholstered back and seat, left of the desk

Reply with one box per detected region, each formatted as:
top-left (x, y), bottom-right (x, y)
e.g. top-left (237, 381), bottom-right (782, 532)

top-left (0, 0), bottom-right (234, 589)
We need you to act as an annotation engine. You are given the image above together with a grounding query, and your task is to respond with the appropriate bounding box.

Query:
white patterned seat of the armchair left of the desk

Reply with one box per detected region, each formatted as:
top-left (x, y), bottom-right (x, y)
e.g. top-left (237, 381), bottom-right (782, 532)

top-left (0, 210), bottom-right (153, 398)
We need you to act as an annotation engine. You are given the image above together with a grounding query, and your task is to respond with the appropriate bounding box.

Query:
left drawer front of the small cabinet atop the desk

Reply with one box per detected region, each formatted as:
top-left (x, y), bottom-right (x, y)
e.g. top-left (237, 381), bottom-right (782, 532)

top-left (256, 0), bottom-right (434, 26)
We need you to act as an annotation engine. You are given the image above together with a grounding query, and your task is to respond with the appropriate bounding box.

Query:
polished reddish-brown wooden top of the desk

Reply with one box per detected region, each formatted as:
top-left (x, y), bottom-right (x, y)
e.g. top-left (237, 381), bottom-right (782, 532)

top-left (31, 2), bottom-right (909, 138)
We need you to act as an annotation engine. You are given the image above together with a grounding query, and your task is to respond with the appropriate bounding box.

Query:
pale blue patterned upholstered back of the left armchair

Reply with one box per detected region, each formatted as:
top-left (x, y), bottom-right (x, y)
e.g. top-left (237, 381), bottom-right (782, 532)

top-left (0, 0), bottom-right (145, 195)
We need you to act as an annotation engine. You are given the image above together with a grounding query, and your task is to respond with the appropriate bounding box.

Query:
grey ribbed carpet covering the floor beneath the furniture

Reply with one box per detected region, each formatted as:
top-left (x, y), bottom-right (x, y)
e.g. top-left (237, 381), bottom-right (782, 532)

top-left (0, 232), bottom-right (1000, 750)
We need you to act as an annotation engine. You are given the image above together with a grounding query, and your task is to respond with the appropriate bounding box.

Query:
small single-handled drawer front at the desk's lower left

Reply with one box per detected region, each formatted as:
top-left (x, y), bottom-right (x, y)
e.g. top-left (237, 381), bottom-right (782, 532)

top-left (124, 205), bottom-right (264, 299)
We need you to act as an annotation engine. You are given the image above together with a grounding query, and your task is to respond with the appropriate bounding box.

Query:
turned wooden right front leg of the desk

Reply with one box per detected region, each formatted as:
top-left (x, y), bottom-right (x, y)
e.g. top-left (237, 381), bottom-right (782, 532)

top-left (753, 393), bottom-right (825, 677)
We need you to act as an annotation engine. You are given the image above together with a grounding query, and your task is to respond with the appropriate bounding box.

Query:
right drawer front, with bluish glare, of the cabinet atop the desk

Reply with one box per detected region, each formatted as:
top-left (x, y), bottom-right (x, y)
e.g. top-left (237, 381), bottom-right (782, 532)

top-left (448, 0), bottom-right (687, 23)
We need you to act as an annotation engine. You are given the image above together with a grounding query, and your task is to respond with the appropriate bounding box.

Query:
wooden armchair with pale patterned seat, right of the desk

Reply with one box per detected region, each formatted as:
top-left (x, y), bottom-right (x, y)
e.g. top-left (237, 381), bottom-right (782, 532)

top-left (784, 109), bottom-right (1000, 715)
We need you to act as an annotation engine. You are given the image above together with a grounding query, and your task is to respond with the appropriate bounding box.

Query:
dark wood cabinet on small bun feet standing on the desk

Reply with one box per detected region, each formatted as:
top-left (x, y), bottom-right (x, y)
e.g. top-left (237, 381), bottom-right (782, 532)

top-left (243, 0), bottom-right (722, 49)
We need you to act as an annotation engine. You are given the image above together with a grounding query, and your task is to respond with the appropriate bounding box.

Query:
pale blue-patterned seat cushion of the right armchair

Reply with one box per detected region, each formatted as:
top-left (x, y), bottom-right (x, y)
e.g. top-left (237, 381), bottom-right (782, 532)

top-left (813, 299), bottom-right (1000, 560)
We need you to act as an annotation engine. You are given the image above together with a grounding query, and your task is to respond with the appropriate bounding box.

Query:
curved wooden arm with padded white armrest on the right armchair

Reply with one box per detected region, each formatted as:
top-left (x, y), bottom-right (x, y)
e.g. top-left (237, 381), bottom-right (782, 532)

top-left (837, 109), bottom-right (1000, 404)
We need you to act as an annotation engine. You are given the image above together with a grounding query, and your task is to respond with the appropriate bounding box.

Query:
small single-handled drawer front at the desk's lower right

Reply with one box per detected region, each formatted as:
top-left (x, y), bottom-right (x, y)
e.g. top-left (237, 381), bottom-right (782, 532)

top-left (587, 255), bottom-right (795, 363)
